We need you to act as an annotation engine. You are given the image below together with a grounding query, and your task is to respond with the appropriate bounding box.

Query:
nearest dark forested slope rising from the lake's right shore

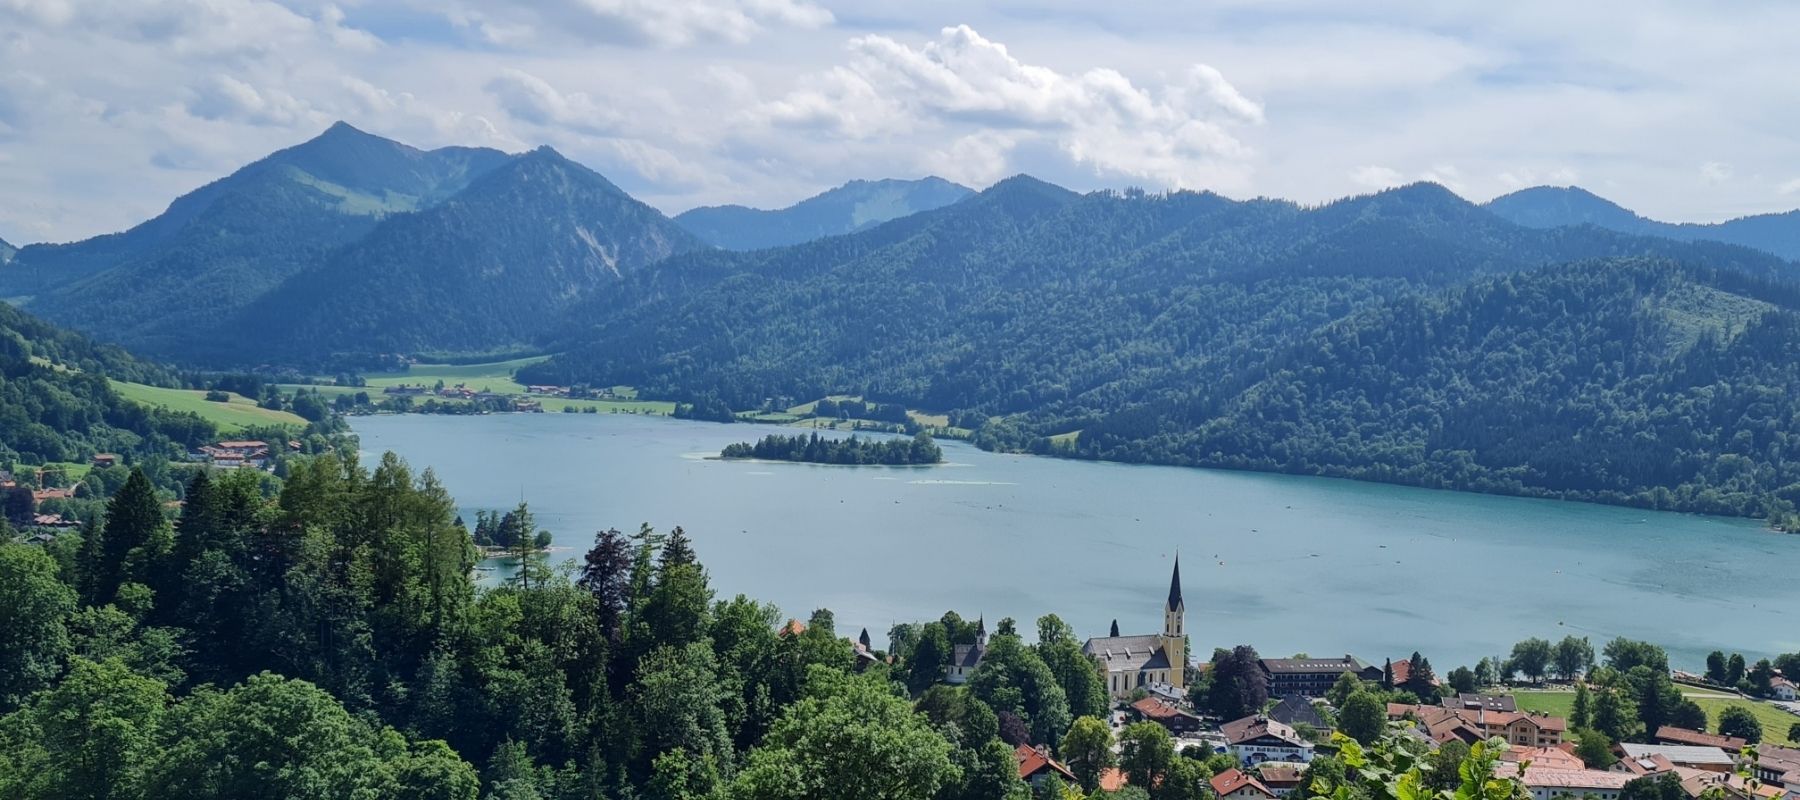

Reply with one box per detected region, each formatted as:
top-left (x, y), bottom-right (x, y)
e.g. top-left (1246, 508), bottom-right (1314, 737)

top-left (1075, 259), bottom-right (1800, 515)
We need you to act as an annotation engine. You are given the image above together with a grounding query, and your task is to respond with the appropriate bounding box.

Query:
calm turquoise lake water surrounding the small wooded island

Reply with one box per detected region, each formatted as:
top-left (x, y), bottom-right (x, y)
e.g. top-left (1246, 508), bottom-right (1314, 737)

top-left (353, 414), bottom-right (1800, 674)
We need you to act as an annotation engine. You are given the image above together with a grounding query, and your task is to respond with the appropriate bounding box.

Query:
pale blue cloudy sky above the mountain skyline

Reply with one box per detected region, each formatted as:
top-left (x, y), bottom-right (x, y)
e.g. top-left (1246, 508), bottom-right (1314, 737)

top-left (0, 0), bottom-right (1800, 243)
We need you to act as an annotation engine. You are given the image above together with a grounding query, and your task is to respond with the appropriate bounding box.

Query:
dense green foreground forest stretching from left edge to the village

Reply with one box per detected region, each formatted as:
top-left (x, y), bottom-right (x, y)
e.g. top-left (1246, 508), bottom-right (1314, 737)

top-left (0, 454), bottom-right (1611, 800)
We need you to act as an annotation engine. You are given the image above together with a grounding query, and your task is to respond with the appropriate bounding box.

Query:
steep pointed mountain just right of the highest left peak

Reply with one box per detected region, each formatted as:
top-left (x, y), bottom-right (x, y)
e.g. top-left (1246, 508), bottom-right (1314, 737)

top-left (232, 148), bottom-right (706, 362)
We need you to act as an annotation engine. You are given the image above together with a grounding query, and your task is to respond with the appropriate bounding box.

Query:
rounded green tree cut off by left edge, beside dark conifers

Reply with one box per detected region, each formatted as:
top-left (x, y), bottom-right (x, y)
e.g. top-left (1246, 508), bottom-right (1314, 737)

top-left (0, 542), bottom-right (76, 712)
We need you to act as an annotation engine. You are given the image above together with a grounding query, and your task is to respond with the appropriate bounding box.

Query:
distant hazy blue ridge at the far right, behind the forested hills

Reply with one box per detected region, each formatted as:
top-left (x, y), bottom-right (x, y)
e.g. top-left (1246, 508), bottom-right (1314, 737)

top-left (1487, 186), bottom-right (1800, 259)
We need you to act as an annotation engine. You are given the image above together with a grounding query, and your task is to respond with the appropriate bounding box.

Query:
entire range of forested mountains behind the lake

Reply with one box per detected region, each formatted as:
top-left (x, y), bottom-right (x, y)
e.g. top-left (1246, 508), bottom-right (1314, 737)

top-left (0, 124), bottom-right (1800, 524)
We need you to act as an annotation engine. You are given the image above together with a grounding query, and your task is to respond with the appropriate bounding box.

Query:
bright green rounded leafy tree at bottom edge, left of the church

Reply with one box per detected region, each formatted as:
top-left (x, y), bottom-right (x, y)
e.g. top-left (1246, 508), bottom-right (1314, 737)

top-left (731, 667), bottom-right (964, 800)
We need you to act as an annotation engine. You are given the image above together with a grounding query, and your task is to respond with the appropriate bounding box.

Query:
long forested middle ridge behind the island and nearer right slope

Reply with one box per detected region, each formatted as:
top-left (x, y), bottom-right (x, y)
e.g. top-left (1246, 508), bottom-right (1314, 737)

top-left (529, 177), bottom-right (1786, 418)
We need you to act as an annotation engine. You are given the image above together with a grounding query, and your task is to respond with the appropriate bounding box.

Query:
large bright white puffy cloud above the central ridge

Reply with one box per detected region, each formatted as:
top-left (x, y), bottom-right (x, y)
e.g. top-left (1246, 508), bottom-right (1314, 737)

top-left (756, 25), bottom-right (1264, 187)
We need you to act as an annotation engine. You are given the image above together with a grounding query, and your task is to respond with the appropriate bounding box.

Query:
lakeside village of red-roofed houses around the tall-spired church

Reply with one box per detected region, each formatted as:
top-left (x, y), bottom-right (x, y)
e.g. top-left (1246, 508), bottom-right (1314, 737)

top-left (907, 559), bottom-right (1800, 800)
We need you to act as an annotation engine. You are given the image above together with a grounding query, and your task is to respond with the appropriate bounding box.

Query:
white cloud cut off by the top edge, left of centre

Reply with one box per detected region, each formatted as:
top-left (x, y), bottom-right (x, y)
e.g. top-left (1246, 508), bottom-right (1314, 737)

top-left (448, 0), bottom-right (833, 47)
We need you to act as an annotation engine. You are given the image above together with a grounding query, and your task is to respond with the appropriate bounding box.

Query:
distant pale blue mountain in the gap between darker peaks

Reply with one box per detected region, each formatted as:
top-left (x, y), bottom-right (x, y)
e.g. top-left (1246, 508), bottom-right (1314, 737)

top-left (675, 177), bottom-right (972, 250)
